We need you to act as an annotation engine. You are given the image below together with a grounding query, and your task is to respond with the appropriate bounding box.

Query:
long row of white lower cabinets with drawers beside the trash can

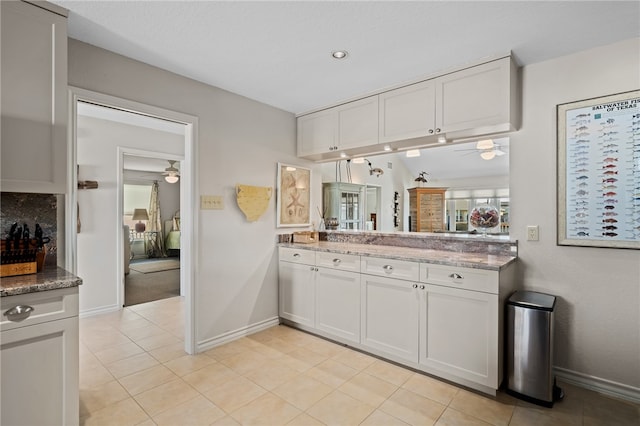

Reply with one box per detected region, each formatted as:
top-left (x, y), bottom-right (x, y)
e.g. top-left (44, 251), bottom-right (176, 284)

top-left (280, 247), bottom-right (514, 394)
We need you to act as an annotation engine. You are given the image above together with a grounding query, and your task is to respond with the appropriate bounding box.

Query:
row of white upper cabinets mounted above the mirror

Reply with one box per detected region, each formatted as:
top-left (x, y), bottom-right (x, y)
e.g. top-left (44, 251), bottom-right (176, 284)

top-left (298, 53), bottom-right (520, 161)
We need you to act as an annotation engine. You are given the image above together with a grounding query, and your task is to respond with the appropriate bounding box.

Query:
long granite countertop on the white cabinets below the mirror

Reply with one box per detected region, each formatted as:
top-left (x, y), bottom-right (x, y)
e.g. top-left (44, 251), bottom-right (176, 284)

top-left (280, 241), bottom-right (517, 271)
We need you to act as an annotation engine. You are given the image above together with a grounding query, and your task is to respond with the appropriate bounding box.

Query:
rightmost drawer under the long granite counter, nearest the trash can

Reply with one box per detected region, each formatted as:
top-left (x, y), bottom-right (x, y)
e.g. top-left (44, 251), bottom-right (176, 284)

top-left (420, 263), bottom-right (499, 294)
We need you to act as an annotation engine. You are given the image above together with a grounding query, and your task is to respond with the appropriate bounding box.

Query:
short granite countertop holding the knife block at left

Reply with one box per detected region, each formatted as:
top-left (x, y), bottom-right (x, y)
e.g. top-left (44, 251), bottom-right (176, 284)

top-left (0, 267), bottom-right (82, 297)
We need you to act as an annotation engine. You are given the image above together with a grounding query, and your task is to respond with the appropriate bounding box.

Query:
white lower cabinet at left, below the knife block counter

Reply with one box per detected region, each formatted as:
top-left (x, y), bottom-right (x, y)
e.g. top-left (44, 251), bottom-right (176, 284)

top-left (0, 287), bottom-right (79, 426)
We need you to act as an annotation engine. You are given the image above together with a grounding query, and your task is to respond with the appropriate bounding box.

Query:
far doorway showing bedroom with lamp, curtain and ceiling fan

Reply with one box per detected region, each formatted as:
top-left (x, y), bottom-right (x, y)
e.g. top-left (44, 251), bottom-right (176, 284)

top-left (122, 153), bottom-right (184, 307)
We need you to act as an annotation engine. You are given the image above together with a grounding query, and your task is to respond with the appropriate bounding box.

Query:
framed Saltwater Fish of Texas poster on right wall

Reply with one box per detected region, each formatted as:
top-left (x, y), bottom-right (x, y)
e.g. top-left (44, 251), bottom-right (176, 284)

top-left (557, 90), bottom-right (640, 249)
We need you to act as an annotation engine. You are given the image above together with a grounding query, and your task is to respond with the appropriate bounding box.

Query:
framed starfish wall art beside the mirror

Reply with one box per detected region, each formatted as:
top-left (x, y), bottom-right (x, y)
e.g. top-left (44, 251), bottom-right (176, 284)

top-left (276, 163), bottom-right (311, 228)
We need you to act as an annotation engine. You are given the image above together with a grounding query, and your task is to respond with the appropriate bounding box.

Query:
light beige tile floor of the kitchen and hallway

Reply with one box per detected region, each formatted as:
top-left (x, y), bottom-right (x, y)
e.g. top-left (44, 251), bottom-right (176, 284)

top-left (80, 297), bottom-right (640, 426)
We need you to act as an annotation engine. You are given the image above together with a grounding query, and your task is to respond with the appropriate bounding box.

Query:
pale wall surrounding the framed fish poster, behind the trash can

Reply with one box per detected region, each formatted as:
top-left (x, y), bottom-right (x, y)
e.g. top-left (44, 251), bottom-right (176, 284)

top-left (510, 39), bottom-right (640, 392)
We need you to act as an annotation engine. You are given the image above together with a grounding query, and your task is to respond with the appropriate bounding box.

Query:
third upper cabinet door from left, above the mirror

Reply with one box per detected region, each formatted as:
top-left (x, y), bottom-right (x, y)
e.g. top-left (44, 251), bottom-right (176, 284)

top-left (379, 80), bottom-right (436, 143)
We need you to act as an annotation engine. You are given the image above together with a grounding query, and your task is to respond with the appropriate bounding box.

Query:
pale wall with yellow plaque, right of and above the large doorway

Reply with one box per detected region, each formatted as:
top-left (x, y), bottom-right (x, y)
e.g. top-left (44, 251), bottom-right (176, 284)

top-left (69, 39), bottom-right (320, 345)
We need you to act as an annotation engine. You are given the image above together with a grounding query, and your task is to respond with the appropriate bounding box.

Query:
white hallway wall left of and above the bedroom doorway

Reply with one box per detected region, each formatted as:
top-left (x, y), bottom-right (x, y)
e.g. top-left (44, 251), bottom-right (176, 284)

top-left (77, 116), bottom-right (184, 314)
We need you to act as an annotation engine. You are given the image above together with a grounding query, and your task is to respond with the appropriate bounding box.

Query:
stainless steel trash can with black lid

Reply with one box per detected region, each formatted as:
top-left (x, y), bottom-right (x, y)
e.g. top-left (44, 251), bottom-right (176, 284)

top-left (506, 291), bottom-right (562, 407)
